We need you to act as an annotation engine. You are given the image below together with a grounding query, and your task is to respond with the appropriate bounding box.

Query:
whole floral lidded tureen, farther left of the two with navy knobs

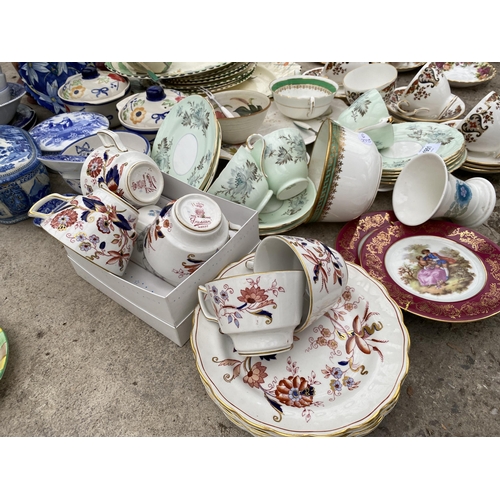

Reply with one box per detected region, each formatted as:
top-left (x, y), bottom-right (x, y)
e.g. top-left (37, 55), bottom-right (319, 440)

top-left (57, 66), bottom-right (130, 128)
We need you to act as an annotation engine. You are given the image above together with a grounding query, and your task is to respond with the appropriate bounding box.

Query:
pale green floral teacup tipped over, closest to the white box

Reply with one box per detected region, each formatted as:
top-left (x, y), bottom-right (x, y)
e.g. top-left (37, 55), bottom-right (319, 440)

top-left (208, 147), bottom-right (273, 212)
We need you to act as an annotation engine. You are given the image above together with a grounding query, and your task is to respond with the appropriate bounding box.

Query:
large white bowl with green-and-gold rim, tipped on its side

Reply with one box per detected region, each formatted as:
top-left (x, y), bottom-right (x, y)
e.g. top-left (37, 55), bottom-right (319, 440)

top-left (307, 118), bottom-right (382, 222)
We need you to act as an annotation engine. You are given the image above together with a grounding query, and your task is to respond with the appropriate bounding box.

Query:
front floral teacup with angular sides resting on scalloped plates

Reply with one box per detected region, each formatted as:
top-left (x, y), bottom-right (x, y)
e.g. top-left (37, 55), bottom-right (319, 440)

top-left (198, 270), bottom-right (305, 356)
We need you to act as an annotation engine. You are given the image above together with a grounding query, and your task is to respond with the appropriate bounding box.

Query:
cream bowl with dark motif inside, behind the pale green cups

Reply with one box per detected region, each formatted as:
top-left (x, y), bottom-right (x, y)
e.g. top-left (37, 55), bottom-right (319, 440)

top-left (214, 90), bottom-right (271, 144)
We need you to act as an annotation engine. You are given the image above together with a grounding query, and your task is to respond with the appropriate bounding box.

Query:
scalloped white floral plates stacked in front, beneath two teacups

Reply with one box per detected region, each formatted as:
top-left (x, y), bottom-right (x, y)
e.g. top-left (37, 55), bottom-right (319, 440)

top-left (191, 255), bottom-right (410, 436)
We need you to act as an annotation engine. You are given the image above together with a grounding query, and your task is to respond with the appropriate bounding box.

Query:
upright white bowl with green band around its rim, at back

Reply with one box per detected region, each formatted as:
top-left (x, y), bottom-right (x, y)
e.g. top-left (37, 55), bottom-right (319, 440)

top-left (269, 75), bottom-right (339, 120)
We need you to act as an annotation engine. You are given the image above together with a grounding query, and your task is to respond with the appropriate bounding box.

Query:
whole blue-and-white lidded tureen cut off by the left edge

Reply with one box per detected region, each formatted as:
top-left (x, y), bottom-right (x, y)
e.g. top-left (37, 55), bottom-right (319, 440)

top-left (0, 125), bottom-right (50, 224)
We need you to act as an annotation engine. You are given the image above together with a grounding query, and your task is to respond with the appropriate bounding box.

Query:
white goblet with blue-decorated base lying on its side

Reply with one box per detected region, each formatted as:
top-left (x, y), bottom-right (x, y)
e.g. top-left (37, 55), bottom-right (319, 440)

top-left (392, 153), bottom-right (496, 227)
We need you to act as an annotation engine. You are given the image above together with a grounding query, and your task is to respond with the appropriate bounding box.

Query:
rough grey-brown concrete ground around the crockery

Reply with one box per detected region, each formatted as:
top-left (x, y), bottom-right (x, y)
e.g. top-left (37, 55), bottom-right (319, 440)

top-left (0, 63), bottom-right (500, 437)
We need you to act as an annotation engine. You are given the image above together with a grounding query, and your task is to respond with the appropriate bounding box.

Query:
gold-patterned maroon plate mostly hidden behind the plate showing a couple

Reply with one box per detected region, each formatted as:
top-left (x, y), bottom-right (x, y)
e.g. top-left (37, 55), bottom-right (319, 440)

top-left (335, 211), bottom-right (398, 265)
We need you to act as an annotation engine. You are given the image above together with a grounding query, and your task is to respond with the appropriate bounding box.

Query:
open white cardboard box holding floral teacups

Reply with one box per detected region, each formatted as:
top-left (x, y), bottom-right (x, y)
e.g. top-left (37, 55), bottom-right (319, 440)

top-left (66, 174), bottom-right (260, 346)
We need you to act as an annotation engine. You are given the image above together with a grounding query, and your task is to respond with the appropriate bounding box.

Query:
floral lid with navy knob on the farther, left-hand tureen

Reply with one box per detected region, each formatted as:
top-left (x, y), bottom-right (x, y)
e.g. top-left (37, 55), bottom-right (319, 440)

top-left (57, 66), bottom-right (130, 104)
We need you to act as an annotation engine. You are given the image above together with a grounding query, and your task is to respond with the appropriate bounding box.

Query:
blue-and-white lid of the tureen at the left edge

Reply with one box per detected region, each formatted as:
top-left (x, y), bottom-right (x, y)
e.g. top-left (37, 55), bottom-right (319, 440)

top-left (0, 125), bottom-right (40, 184)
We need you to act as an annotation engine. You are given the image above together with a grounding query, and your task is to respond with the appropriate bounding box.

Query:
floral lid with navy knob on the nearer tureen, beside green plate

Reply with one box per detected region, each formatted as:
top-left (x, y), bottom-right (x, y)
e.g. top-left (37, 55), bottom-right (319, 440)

top-left (117, 85), bottom-right (185, 130)
